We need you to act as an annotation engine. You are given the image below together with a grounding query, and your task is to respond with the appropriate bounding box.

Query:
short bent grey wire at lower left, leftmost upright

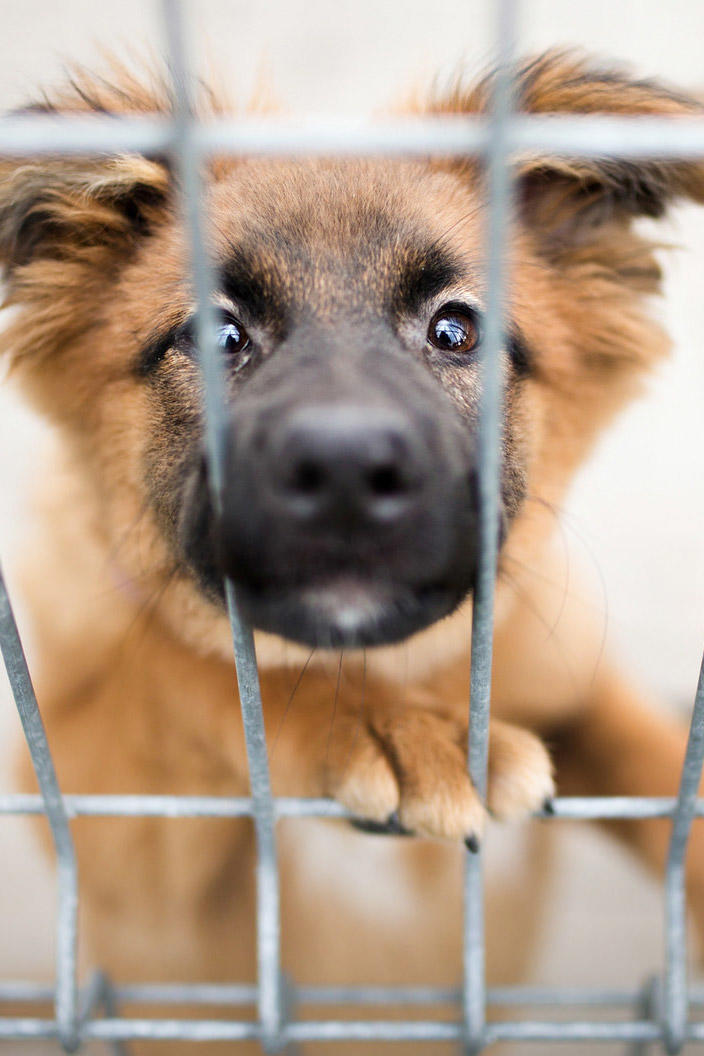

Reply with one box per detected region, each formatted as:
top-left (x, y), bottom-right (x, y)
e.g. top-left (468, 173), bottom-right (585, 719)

top-left (0, 569), bottom-right (78, 1052)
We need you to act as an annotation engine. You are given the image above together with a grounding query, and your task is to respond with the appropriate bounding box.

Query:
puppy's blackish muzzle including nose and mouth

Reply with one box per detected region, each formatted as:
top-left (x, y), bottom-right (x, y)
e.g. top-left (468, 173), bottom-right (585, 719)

top-left (179, 333), bottom-right (476, 646)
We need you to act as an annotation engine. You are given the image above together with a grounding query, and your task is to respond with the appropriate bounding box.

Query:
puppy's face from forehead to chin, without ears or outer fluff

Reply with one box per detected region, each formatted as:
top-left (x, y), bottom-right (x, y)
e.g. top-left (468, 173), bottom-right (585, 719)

top-left (162, 164), bottom-right (525, 645)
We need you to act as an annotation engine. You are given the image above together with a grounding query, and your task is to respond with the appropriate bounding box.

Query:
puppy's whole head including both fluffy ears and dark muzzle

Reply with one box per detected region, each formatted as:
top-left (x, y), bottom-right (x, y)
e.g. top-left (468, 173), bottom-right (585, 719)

top-left (0, 55), bottom-right (704, 646)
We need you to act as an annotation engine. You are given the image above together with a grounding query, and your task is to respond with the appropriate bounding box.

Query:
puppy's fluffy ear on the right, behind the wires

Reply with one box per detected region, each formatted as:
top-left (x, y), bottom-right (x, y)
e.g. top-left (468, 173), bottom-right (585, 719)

top-left (432, 51), bottom-right (704, 249)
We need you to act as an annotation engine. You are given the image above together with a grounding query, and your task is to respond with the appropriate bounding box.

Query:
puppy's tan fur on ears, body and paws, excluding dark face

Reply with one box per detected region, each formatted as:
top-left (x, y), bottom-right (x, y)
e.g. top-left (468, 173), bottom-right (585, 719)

top-left (0, 54), bottom-right (704, 1053)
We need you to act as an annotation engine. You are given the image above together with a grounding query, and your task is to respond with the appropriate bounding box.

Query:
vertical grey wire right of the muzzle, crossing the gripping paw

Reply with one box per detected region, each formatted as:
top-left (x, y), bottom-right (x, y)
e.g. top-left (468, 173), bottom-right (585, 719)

top-left (463, 0), bottom-right (517, 1053)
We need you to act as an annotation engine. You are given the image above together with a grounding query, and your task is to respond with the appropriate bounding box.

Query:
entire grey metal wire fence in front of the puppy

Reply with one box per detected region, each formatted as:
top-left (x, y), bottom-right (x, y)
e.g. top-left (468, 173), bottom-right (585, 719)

top-left (0, 0), bottom-right (704, 1056)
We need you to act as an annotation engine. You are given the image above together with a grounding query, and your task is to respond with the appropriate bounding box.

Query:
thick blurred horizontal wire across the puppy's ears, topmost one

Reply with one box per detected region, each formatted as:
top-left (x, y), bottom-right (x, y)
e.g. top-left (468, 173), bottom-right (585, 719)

top-left (0, 114), bottom-right (704, 158)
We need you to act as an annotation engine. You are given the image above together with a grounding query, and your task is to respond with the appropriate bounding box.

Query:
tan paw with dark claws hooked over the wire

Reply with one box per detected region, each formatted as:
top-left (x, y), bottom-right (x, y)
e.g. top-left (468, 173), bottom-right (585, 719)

top-left (327, 706), bottom-right (554, 850)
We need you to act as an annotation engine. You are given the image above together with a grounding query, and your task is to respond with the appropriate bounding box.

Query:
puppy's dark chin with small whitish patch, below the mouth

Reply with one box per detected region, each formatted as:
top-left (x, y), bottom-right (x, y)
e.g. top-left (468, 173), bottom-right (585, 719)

top-left (237, 579), bottom-right (464, 648)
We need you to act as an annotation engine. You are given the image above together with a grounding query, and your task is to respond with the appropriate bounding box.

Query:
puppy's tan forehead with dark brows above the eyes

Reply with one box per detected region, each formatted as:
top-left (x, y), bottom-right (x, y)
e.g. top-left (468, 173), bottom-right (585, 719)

top-left (203, 162), bottom-right (474, 314)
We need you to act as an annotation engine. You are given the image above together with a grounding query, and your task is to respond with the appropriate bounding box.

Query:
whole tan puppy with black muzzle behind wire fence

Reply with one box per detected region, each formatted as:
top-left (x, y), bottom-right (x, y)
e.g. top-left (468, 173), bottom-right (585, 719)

top-left (0, 53), bottom-right (704, 1053)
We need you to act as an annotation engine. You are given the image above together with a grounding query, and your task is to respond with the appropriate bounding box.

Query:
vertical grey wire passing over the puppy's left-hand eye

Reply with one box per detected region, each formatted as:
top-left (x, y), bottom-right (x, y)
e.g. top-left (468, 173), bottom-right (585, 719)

top-left (159, 0), bottom-right (283, 1052)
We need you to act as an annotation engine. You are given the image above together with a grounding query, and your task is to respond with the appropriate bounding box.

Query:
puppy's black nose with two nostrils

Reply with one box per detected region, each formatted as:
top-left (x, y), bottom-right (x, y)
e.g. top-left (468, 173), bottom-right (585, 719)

top-left (269, 404), bottom-right (429, 523)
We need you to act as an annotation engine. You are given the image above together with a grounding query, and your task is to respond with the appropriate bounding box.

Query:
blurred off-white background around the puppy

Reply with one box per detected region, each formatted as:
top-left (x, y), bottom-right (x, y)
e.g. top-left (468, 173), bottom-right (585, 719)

top-left (0, 0), bottom-right (704, 1056)
